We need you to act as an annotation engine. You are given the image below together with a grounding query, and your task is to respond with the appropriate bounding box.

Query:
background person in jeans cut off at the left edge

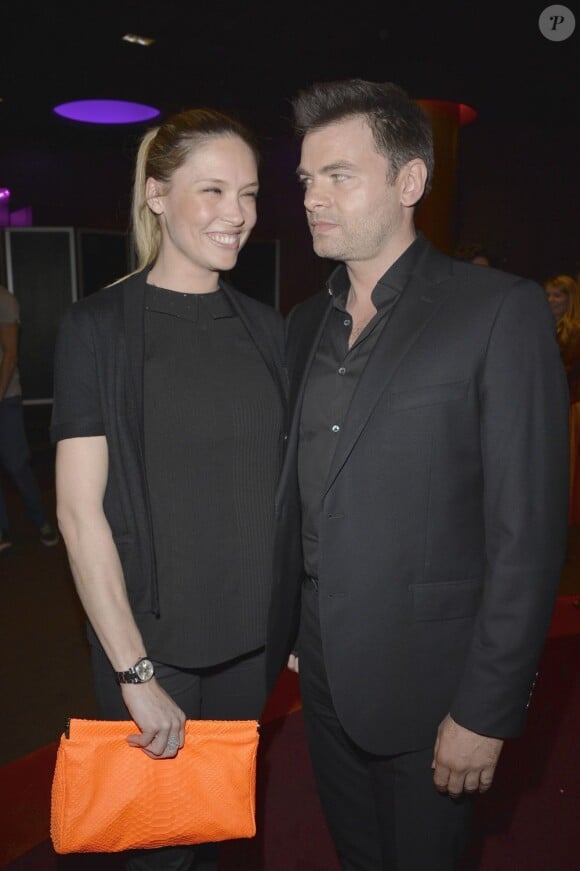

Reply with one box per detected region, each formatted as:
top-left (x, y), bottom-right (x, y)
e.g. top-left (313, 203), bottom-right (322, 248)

top-left (0, 284), bottom-right (59, 554)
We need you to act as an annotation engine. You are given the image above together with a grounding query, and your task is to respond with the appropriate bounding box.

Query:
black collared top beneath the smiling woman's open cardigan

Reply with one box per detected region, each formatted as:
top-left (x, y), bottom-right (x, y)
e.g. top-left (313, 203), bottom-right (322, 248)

top-left (137, 286), bottom-right (283, 668)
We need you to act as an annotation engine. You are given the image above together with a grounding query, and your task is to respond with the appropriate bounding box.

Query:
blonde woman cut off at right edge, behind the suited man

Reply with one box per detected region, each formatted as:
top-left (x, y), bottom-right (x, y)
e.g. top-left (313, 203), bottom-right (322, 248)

top-left (544, 275), bottom-right (580, 526)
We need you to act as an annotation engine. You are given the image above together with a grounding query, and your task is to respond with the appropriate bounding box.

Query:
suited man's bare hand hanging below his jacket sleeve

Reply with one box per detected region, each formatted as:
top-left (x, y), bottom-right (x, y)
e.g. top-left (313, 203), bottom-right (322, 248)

top-left (431, 714), bottom-right (503, 798)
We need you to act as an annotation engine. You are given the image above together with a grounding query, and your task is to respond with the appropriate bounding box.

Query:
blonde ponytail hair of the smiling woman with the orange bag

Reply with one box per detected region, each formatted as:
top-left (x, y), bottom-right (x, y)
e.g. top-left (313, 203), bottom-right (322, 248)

top-left (131, 108), bottom-right (260, 271)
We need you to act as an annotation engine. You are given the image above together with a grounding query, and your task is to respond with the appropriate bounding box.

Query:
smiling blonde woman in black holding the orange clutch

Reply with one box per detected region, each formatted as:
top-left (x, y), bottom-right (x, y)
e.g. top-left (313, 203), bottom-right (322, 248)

top-left (51, 109), bottom-right (285, 871)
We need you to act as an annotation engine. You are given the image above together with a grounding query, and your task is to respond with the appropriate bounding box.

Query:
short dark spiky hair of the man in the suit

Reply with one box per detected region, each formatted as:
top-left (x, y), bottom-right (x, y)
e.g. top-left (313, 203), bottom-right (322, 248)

top-left (292, 79), bottom-right (434, 193)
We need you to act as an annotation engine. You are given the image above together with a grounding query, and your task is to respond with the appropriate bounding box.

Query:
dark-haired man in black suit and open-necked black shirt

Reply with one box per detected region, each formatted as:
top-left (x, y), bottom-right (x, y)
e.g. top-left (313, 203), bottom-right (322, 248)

top-left (269, 80), bottom-right (568, 871)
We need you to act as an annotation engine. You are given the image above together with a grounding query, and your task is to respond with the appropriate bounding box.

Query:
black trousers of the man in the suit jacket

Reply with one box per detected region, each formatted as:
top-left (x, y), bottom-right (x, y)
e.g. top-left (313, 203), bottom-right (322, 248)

top-left (298, 583), bottom-right (473, 871)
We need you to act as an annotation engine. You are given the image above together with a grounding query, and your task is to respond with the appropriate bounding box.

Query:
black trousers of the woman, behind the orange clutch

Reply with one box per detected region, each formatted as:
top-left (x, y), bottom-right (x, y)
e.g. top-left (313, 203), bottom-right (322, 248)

top-left (91, 644), bottom-right (266, 871)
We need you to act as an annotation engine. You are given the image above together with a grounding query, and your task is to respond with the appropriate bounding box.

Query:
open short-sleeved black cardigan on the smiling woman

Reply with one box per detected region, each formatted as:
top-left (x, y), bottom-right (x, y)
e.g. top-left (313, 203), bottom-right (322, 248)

top-left (50, 270), bottom-right (287, 614)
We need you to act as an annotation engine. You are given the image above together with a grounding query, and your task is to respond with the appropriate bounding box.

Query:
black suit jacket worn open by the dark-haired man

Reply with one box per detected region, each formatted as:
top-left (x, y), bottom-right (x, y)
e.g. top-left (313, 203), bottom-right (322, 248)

top-left (269, 240), bottom-right (568, 754)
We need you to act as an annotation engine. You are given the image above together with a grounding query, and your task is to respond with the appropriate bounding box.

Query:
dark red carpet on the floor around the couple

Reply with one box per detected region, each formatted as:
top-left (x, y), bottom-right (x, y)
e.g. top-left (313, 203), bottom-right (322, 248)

top-left (0, 596), bottom-right (580, 871)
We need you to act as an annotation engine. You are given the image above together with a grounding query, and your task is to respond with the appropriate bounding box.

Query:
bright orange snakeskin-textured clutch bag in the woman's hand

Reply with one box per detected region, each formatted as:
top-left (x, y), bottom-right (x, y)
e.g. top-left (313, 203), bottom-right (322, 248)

top-left (50, 719), bottom-right (259, 853)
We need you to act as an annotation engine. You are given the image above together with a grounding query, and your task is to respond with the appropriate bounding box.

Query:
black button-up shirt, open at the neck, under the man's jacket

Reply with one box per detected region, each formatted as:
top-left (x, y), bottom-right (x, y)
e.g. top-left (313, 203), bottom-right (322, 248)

top-left (298, 235), bottom-right (426, 578)
